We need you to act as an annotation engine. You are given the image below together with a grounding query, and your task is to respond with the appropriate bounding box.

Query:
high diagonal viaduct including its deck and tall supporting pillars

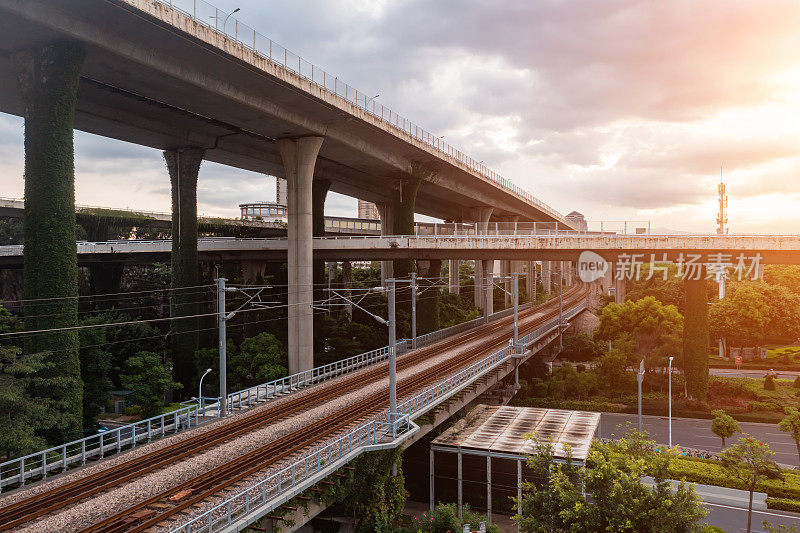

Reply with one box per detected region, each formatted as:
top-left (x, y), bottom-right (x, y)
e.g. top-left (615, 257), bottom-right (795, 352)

top-left (0, 0), bottom-right (571, 378)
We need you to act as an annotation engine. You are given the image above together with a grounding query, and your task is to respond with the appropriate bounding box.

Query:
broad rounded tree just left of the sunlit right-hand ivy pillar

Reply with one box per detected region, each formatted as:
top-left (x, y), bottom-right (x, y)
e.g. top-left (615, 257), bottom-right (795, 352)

top-left (595, 296), bottom-right (683, 364)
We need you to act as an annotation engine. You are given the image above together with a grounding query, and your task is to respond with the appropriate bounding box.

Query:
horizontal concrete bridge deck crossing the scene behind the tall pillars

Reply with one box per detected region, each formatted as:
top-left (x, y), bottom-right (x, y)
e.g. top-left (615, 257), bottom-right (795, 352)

top-left (0, 234), bottom-right (800, 268)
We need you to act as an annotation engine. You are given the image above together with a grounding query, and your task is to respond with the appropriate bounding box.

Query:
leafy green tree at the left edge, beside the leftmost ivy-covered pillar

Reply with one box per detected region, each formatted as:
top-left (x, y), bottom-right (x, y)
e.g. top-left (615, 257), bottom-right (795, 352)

top-left (0, 346), bottom-right (55, 457)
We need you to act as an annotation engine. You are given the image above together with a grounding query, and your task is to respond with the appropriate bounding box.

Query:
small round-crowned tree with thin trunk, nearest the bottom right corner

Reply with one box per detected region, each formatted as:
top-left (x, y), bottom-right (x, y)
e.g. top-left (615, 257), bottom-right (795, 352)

top-left (719, 433), bottom-right (782, 533)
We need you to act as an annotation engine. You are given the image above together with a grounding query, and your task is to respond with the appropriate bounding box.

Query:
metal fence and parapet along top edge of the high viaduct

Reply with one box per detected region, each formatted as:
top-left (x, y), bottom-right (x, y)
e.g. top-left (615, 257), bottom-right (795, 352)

top-left (125, 0), bottom-right (568, 224)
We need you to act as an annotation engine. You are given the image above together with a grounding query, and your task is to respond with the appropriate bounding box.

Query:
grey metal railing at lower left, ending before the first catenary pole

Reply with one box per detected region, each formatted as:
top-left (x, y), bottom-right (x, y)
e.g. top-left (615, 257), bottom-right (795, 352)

top-left (0, 406), bottom-right (200, 491)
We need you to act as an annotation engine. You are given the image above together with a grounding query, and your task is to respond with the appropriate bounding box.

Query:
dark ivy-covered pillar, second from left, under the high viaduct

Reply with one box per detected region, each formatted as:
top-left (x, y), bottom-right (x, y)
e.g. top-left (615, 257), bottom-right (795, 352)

top-left (164, 148), bottom-right (205, 390)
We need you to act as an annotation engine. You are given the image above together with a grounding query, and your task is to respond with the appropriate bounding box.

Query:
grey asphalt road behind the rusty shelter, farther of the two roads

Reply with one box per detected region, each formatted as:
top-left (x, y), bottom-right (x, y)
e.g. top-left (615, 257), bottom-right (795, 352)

top-left (599, 413), bottom-right (800, 466)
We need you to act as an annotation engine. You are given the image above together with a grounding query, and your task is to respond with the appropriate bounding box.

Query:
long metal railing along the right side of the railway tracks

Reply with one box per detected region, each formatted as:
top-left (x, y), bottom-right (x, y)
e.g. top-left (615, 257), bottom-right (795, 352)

top-left (171, 302), bottom-right (585, 533)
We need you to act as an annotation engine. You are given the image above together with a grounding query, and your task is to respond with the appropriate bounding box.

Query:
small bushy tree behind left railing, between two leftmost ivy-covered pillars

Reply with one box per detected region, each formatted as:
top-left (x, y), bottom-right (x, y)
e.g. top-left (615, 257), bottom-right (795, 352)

top-left (122, 352), bottom-right (181, 418)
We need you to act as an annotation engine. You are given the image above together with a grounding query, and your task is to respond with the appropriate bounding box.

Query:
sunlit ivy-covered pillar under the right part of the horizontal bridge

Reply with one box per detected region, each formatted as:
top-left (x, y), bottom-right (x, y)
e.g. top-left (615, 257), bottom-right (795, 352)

top-left (683, 273), bottom-right (711, 400)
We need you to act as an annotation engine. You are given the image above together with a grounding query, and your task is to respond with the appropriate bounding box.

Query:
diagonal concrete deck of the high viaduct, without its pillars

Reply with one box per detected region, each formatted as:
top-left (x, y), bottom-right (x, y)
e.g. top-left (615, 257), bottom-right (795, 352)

top-left (0, 0), bottom-right (570, 227)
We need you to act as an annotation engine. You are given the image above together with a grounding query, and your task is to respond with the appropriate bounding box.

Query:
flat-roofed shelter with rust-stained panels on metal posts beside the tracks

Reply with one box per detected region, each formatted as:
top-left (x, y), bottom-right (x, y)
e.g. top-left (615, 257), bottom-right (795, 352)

top-left (430, 405), bottom-right (600, 522)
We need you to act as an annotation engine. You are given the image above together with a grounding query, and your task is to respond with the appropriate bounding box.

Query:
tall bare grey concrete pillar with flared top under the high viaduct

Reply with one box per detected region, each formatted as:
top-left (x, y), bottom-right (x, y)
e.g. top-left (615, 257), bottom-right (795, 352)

top-left (278, 137), bottom-right (323, 374)
